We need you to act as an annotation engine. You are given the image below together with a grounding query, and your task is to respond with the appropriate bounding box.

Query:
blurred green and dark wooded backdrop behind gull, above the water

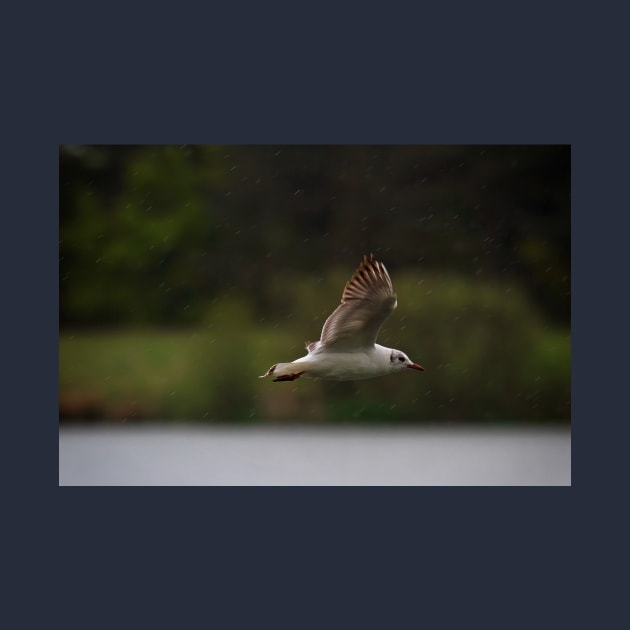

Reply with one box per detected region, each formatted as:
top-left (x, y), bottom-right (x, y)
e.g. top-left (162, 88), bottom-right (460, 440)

top-left (59, 145), bottom-right (571, 427)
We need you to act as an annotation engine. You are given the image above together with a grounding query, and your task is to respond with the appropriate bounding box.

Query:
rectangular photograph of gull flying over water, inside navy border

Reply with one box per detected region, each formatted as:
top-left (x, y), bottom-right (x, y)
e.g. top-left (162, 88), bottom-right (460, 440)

top-left (59, 144), bottom-right (571, 486)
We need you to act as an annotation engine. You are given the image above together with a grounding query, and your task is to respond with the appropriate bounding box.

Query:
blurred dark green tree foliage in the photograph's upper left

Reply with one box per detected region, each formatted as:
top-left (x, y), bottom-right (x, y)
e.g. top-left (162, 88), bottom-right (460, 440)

top-left (60, 147), bottom-right (222, 324)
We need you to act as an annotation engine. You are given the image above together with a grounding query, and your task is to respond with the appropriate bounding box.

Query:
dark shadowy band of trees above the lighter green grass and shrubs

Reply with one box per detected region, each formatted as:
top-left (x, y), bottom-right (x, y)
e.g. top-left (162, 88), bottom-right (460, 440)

top-left (60, 145), bottom-right (570, 325)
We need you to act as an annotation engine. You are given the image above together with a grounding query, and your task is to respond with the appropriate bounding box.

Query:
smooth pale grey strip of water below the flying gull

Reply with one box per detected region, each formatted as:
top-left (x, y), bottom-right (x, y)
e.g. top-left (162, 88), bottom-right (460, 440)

top-left (59, 425), bottom-right (571, 486)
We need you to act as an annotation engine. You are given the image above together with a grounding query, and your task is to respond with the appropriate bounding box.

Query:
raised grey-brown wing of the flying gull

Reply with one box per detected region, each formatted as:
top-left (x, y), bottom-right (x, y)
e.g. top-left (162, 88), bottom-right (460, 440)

top-left (307, 255), bottom-right (396, 353)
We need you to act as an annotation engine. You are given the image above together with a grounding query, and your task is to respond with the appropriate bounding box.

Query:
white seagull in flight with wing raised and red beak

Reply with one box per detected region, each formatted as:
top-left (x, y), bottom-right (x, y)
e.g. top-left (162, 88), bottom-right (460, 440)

top-left (258, 254), bottom-right (424, 381)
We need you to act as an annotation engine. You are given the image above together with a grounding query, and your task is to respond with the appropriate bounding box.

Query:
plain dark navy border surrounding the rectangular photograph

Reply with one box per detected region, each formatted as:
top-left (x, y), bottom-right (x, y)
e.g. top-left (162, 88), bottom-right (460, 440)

top-left (3, 2), bottom-right (628, 628)
